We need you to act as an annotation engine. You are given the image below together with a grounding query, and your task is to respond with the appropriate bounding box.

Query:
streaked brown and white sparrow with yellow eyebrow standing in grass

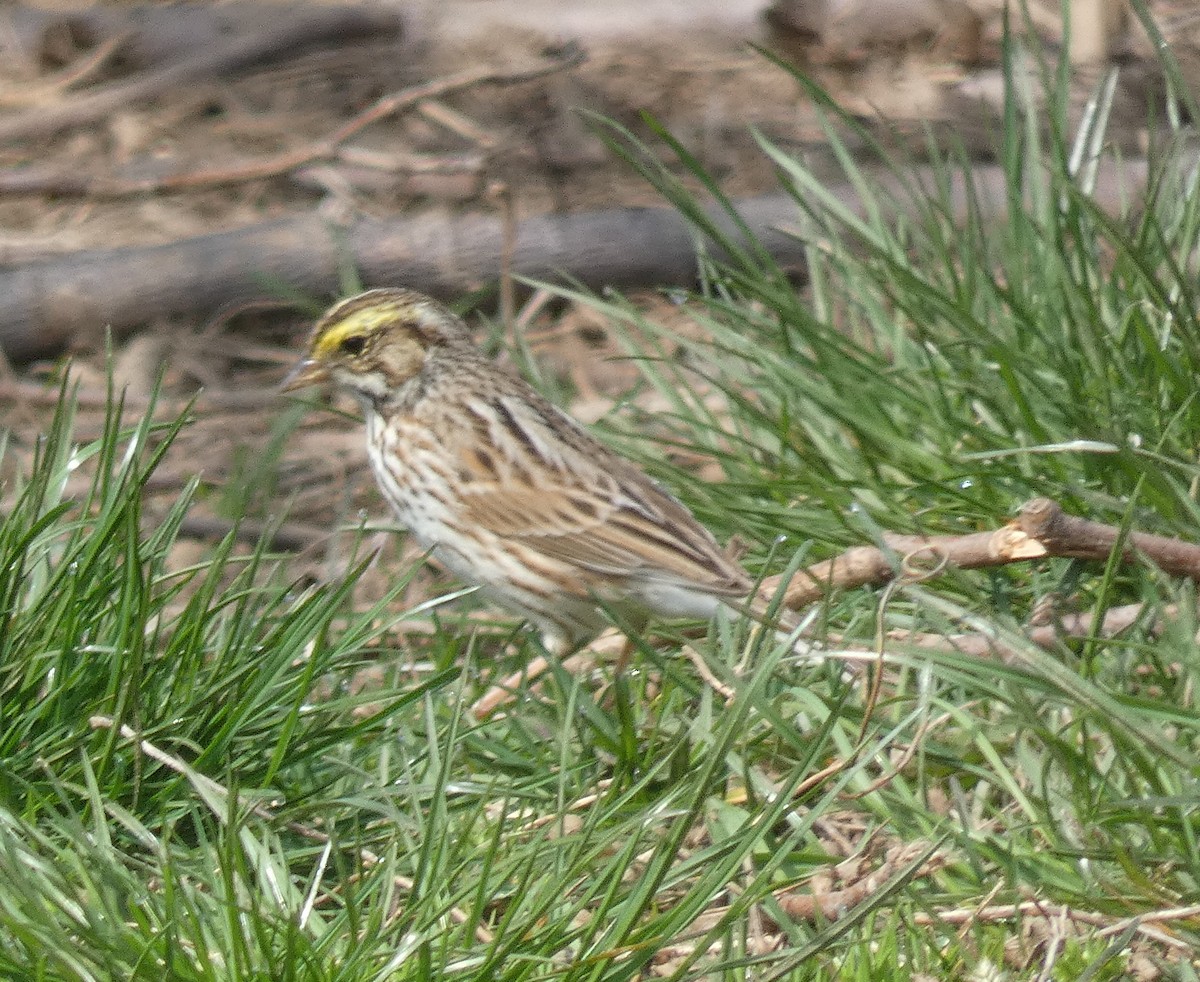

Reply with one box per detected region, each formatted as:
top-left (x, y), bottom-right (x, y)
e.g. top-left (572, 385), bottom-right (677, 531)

top-left (284, 289), bottom-right (752, 654)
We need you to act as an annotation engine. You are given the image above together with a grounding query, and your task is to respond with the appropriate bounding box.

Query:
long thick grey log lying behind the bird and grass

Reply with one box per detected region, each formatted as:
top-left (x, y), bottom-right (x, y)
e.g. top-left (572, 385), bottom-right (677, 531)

top-left (0, 161), bottom-right (1147, 361)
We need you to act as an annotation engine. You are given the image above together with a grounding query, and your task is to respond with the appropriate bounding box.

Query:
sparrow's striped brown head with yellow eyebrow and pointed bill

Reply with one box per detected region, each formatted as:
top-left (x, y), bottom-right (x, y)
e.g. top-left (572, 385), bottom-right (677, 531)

top-left (283, 289), bottom-right (470, 402)
